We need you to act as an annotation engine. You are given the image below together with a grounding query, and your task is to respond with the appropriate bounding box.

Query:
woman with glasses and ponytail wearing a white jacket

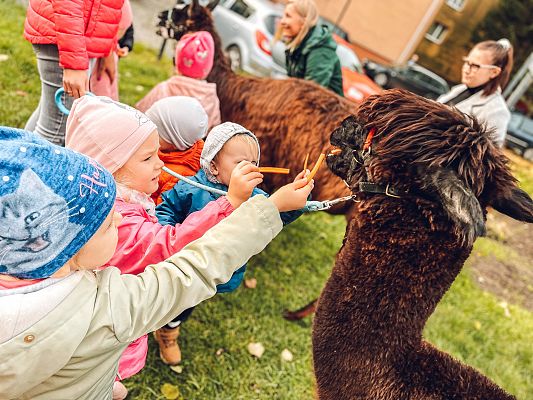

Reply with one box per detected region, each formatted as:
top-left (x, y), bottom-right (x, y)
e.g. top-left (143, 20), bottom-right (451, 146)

top-left (437, 39), bottom-right (513, 147)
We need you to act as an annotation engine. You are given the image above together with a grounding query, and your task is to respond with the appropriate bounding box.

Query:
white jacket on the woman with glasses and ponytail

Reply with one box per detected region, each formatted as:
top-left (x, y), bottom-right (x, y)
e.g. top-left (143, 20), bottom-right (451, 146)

top-left (437, 84), bottom-right (511, 147)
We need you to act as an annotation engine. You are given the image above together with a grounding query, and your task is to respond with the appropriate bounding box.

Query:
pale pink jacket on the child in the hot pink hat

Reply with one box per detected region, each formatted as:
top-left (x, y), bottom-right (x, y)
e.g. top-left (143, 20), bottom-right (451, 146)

top-left (135, 75), bottom-right (220, 130)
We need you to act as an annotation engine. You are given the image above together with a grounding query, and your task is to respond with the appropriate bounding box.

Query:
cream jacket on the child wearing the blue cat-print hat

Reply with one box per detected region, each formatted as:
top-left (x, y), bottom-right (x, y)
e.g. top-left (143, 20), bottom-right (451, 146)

top-left (0, 196), bottom-right (282, 400)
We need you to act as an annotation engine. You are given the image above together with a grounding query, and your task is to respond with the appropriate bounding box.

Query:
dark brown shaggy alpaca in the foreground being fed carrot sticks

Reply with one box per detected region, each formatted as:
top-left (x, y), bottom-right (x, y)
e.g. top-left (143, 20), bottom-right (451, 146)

top-left (313, 90), bottom-right (533, 400)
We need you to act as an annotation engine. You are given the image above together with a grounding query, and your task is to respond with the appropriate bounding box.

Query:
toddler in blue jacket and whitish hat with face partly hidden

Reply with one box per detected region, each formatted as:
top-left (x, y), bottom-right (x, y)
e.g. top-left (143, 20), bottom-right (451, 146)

top-left (156, 122), bottom-right (302, 365)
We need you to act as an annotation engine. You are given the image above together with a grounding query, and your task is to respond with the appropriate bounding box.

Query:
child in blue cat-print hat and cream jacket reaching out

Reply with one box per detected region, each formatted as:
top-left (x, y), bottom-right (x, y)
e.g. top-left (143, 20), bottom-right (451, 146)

top-left (0, 128), bottom-right (312, 399)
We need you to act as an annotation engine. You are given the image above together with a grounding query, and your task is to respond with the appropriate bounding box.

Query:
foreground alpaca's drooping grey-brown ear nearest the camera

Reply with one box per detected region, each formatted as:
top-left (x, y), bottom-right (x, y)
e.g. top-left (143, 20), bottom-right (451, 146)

top-left (420, 168), bottom-right (485, 246)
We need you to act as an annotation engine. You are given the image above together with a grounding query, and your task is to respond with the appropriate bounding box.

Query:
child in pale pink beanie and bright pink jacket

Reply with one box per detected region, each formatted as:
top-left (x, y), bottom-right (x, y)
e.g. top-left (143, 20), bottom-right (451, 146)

top-left (65, 96), bottom-right (237, 399)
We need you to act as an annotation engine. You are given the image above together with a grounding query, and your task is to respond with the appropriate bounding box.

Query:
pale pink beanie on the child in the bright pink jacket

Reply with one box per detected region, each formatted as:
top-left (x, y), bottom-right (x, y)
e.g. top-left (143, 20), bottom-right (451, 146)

top-left (65, 96), bottom-right (157, 173)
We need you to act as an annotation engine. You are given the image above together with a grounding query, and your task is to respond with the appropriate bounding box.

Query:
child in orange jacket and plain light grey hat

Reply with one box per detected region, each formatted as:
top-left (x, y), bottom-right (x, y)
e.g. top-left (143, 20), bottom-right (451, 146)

top-left (146, 96), bottom-right (207, 204)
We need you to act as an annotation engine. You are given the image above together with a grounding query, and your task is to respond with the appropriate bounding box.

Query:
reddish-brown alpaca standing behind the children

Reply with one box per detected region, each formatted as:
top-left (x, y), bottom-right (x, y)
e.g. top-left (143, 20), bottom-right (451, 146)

top-left (166, 0), bottom-right (356, 212)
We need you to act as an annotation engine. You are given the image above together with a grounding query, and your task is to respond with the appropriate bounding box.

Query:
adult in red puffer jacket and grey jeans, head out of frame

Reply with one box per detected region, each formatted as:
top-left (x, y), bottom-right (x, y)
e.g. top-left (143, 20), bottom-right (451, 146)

top-left (24, 0), bottom-right (124, 146)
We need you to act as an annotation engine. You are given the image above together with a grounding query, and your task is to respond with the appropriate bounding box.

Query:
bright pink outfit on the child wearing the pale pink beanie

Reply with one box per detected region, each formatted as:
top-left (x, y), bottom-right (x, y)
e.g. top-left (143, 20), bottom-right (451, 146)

top-left (106, 197), bottom-right (233, 380)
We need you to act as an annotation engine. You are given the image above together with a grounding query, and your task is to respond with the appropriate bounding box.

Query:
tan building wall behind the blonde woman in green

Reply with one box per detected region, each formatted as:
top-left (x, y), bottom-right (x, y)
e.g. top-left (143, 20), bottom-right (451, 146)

top-left (315, 0), bottom-right (444, 64)
